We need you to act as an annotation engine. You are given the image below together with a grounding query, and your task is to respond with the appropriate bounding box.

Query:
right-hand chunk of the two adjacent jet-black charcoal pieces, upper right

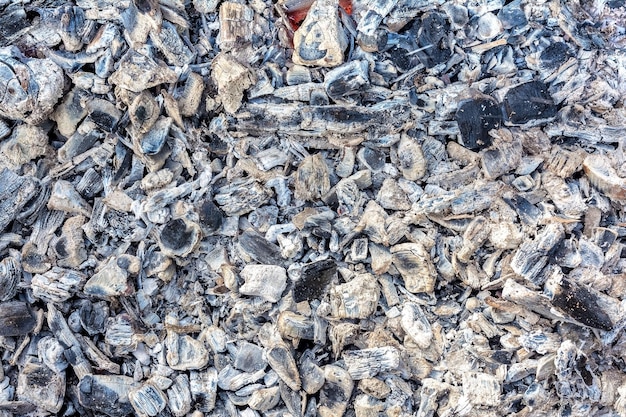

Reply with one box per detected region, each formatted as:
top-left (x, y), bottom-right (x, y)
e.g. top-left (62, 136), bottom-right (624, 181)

top-left (502, 81), bottom-right (557, 124)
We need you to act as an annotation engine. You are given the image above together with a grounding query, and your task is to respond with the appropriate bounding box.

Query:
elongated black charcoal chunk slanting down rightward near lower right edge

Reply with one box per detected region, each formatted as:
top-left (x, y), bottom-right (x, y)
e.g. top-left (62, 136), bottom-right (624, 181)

top-left (552, 279), bottom-right (613, 331)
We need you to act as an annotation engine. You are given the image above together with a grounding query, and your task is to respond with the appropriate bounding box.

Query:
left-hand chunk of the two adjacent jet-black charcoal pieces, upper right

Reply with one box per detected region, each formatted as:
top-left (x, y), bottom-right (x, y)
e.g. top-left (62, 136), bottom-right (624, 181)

top-left (455, 98), bottom-right (502, 150)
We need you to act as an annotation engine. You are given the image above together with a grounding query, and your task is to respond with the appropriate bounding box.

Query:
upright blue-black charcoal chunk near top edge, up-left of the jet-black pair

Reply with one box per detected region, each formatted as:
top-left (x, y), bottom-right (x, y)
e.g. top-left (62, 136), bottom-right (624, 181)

top-left (417, 12), bottom-right (452, 68)
